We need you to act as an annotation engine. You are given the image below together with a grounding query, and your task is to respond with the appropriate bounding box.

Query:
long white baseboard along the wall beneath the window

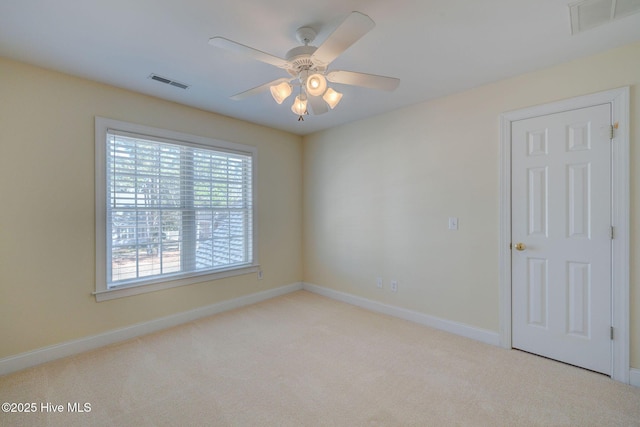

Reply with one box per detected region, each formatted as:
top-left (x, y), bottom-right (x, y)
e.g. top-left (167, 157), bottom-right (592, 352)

top-left (0, 283), bottom-right (303, 375)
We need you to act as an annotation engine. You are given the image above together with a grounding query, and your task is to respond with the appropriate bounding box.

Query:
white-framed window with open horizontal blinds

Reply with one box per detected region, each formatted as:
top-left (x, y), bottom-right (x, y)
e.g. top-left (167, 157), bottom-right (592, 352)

top-left (96, 117), bottom-right (257, 301)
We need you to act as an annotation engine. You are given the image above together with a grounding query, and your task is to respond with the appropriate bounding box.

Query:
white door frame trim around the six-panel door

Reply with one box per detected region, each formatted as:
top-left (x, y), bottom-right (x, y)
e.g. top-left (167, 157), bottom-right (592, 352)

top-left (499, 86), bottom-right (630, 384)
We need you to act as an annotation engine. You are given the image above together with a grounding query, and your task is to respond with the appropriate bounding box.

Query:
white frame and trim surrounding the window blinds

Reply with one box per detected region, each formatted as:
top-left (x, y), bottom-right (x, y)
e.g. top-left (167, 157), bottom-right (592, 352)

top-left (93, 116), bottom-right (260, 302)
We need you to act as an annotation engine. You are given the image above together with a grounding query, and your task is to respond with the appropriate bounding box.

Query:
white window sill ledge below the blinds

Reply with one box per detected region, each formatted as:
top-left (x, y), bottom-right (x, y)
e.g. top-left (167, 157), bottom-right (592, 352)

top-left (93, 265), bottom-right (260, 302)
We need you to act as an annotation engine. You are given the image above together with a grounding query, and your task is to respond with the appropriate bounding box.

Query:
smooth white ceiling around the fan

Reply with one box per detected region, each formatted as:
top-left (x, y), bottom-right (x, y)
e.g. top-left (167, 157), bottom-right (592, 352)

top-left (0, 0), bottom-right (640, 135)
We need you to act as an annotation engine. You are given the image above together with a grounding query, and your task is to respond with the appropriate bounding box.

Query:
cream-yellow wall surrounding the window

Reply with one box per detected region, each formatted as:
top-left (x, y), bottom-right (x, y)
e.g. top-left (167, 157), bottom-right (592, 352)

top-left (0, 59), bottom-right (302, 358)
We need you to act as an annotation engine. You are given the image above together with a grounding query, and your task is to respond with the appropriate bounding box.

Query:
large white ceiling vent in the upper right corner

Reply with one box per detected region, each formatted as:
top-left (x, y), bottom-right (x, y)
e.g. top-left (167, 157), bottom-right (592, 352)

top-left (569, 0), bottom-right (640, 34)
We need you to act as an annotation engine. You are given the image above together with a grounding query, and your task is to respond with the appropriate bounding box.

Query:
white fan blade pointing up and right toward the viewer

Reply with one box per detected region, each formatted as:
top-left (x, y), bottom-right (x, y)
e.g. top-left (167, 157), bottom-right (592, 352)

top-left (311, 12), bottom-right (376, 65)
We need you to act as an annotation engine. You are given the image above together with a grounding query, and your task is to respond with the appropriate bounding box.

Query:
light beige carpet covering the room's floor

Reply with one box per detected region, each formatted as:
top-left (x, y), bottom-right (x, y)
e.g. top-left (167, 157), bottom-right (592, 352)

top-left (0, 291), bottom-right (640, 426)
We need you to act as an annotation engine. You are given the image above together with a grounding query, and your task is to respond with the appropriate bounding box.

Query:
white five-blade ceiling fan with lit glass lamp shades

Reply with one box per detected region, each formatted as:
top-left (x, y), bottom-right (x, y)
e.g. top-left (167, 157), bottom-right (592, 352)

top-left (209, 12), bottom-right (400, 120)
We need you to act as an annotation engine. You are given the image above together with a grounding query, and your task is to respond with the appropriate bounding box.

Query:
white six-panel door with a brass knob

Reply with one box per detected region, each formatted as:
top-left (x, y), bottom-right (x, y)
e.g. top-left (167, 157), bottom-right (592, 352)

top-left (511, 104), bottom-right (612, 374)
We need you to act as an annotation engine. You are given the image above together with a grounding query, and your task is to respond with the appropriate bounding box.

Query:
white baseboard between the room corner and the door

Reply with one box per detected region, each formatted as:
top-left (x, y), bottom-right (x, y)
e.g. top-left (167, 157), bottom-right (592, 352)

top-left (303, 283), bottom-right (500, 346)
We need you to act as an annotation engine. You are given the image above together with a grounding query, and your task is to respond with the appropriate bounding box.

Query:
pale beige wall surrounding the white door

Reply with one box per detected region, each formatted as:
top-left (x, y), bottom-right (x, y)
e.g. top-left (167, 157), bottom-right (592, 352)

top-left (303, 44), bottom-right (640, 368)
